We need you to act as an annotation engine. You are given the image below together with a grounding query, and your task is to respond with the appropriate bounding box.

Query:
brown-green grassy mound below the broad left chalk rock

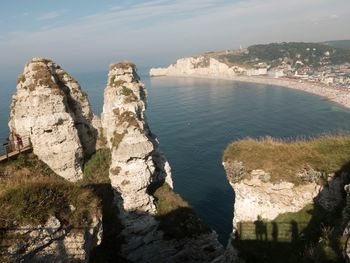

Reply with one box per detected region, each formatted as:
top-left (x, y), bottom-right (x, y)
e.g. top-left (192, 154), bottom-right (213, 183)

top-left (0, 154), bottom-right (99, 228)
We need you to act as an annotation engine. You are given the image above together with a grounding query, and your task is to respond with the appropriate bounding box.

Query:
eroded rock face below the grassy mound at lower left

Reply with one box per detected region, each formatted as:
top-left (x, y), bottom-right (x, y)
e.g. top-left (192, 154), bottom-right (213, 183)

top-left (1, 215), bottom-right (102, 262)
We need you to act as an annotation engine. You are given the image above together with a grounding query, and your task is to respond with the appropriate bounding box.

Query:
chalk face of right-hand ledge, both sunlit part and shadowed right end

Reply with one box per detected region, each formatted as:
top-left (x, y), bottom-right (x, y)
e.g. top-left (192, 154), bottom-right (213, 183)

top-left (223, 160), bottom-right (348, 231)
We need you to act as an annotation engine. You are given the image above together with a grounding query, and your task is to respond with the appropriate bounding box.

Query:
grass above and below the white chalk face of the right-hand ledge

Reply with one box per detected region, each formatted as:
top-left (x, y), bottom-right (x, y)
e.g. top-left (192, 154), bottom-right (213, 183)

top-left (228, 135), bottom-right (350, 263)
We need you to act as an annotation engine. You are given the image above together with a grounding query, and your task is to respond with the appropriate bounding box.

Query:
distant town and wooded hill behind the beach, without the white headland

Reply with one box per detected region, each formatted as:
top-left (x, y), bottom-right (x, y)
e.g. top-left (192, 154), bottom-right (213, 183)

top-left (212, 43), bottom-right (350, 89)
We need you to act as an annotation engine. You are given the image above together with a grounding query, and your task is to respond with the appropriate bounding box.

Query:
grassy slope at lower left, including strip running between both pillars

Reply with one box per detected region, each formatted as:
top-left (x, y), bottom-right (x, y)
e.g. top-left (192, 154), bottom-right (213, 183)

top-left (0, 149), bottom-right (124, 262)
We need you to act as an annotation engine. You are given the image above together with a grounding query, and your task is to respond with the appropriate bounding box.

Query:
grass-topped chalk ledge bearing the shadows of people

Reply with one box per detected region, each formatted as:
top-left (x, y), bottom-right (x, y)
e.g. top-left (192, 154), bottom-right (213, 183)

top-left (223, 136), bottom-right (350, 262)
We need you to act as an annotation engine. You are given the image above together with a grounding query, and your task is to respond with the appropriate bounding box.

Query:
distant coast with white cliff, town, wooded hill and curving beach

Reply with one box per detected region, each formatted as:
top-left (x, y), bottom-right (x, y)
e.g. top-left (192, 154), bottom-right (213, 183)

top-left (150, 42), bottom-right (350, 108)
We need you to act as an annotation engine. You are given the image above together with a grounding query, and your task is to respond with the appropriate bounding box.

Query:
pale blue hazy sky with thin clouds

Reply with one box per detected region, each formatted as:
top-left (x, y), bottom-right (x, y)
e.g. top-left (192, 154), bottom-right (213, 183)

top-left (0, 0), bottom-right (350, 78)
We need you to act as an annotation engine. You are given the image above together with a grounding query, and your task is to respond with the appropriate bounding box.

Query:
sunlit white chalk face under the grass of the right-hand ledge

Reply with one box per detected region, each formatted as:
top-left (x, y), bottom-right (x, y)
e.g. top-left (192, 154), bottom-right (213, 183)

top-left (224, 166), bottom-right (321, 228)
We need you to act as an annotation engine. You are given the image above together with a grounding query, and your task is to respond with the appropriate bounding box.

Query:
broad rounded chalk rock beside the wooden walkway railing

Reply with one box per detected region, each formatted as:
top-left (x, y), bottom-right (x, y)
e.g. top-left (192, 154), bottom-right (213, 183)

top-left (9, 58), bottom-right (97, 181)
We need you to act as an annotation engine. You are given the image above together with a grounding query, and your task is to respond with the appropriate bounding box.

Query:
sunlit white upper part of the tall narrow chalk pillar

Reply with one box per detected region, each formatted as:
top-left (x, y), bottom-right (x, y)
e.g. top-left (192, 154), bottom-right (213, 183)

top-left (101, 62), bottom-right (172, 214)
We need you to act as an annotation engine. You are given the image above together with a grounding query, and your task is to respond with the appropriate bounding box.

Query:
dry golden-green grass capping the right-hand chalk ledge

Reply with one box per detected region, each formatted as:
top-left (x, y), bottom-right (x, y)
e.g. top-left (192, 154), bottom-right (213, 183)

top-left (223, 135), bottom-right (350, 183)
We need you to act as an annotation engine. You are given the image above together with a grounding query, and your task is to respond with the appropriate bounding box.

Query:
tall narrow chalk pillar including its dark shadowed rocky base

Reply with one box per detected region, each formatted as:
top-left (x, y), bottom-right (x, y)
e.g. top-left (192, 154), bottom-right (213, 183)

top-left (101, 62), bottom-right (230, 262)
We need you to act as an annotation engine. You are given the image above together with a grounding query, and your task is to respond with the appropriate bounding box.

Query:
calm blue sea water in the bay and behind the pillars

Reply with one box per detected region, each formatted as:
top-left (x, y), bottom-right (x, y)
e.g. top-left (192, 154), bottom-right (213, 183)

top-left (0, 69), bottom-right (350, 243)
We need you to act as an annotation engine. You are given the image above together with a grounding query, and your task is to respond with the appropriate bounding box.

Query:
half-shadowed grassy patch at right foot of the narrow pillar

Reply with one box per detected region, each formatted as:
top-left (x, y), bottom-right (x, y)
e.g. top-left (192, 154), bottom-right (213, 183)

top-left (153, 183), bottom-right (211, 239)
